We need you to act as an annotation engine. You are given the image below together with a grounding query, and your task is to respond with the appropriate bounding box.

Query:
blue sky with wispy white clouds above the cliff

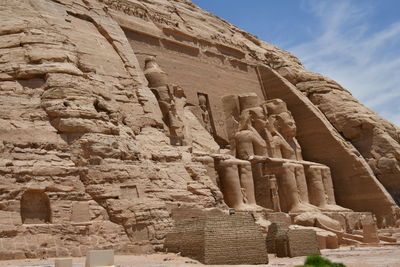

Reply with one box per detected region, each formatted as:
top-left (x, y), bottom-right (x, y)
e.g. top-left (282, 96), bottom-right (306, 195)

top-left (192, 0), bottom-right (400, 126)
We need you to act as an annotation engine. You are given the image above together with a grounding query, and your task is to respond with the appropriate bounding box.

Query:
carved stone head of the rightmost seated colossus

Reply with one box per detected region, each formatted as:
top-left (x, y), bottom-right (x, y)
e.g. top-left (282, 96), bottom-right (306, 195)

top-left (266, 99), bottom-right (297, 138)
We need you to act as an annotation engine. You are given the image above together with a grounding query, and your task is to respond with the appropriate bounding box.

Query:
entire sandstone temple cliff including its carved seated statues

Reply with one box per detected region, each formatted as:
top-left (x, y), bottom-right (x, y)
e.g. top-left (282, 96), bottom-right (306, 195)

top-left (0, 0), bottom-right (400, 264)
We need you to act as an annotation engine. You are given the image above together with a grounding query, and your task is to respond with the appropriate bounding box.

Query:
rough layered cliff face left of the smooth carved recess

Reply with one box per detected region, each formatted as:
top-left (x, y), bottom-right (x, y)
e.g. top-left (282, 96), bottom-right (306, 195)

top-left (0, 1), bottom-right (224, 259)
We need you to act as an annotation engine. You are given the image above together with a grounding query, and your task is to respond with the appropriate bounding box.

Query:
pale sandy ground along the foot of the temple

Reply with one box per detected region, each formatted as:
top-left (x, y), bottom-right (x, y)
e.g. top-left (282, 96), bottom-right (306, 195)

top-left (0, 247), bottom-right (400, 267)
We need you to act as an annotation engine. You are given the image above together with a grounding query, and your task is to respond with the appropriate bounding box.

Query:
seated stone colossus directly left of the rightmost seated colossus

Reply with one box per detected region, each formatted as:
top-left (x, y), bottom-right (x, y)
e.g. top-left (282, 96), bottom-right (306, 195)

top-left (228, 94), bottom-right (318, 212)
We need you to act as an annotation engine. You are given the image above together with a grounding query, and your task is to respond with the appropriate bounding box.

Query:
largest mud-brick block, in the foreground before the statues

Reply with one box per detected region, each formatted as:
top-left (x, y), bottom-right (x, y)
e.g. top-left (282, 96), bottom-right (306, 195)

top-left (164, 214), bottom-right (268, 264)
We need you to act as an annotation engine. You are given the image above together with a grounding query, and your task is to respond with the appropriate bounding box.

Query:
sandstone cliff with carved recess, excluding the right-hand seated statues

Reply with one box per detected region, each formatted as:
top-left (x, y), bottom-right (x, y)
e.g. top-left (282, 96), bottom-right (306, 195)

top-left (0, 0), bottom-right (400, 259)
